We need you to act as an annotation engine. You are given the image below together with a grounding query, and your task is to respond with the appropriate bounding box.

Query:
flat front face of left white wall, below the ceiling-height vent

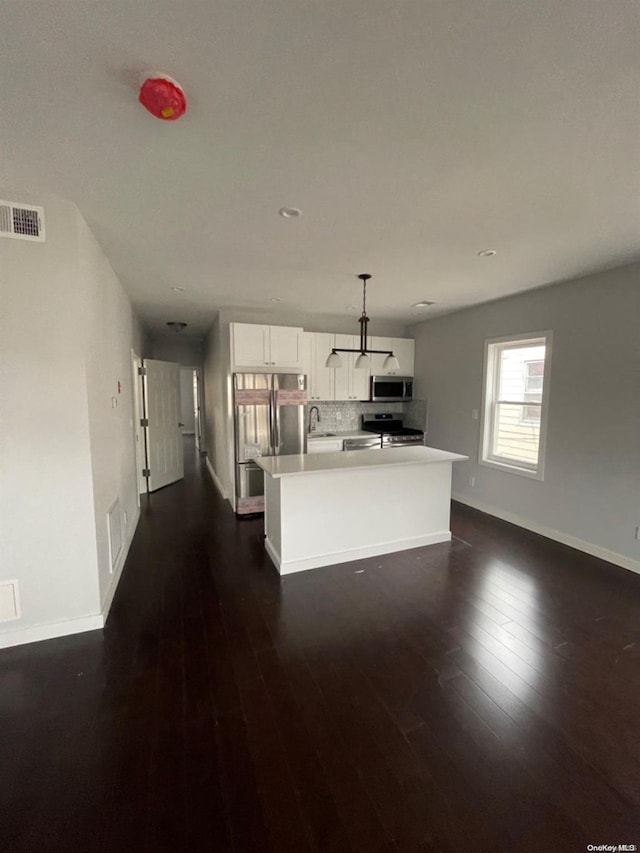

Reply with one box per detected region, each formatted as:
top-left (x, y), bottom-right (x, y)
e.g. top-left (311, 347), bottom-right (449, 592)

top-left (0, 193), bottom-right (100, 645)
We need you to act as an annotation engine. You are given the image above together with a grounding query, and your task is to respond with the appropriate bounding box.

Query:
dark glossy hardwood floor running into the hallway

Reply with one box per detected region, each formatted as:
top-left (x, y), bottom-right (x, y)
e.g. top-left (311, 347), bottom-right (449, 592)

top-left (0, 442), bottom-right (640, 853)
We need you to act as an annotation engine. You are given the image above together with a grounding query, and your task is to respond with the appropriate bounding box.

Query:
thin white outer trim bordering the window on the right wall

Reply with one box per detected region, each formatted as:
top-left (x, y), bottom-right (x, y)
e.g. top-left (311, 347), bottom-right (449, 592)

top-left (478, 329), bottom-right (553, 480)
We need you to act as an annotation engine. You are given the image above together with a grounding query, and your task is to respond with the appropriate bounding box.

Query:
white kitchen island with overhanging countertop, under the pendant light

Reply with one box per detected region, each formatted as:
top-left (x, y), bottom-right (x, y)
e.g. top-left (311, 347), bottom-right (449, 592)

top-left (256, 447), bottom-right (469, 575)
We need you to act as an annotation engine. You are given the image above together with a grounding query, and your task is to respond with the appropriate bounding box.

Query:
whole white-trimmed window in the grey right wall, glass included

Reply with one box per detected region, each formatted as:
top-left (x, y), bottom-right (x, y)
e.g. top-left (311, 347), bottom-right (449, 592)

top-left (480, 332), bottom-right (551, 480)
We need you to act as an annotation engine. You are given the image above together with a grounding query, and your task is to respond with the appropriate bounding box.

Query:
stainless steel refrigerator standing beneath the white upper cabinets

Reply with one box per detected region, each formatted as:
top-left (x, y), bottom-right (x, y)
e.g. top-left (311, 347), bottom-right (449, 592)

top-left (233, 373), bottom-right (307, 515)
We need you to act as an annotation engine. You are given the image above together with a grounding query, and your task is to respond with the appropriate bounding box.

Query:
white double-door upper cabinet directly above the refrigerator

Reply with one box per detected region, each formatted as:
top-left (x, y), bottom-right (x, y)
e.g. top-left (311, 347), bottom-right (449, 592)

top-left (230, 323), bottom-right (303, 371)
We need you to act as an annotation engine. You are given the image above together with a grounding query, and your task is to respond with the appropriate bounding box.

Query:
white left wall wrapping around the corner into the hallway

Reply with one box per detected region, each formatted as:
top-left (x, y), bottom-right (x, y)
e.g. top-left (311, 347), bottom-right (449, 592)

top-left (0, 191), bottom-right (142, 646)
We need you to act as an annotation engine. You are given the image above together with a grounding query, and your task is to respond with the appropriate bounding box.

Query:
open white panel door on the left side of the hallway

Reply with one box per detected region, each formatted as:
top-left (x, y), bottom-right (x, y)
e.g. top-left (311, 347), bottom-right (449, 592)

top-left (144, 358), bottom-right (184, 492)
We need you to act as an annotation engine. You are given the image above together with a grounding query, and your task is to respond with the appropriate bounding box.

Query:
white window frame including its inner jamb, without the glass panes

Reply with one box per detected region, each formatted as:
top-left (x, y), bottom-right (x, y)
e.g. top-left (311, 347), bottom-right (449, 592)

top-left (478, 329), bottom-right (553, 480)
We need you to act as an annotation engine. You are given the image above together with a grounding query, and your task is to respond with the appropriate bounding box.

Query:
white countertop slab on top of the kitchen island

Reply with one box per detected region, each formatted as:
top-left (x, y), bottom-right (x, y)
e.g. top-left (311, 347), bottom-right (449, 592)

top-left (255, 446), bottom-right (469, 477)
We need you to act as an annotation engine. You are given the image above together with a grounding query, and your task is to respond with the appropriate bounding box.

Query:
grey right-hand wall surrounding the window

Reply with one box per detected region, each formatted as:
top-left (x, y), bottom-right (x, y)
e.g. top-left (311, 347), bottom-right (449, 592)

top-left (413, 264), bottom-right (640, 570)
